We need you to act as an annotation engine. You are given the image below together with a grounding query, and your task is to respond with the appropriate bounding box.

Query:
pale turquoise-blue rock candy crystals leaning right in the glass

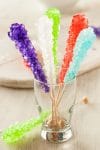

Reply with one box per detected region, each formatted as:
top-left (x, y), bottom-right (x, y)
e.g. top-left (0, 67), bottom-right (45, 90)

top-left (64, 27), bottom-right (96, 83)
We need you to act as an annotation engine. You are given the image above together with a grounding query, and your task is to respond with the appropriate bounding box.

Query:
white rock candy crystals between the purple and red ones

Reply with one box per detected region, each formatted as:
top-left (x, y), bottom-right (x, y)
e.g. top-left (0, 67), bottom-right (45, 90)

top-left (38, 16), bottom-right (56, 84)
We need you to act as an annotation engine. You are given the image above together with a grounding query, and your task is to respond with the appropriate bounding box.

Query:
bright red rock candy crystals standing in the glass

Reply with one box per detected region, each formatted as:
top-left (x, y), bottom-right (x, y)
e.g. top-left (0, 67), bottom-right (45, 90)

top-left (58, 14), bottom-right (88, 83)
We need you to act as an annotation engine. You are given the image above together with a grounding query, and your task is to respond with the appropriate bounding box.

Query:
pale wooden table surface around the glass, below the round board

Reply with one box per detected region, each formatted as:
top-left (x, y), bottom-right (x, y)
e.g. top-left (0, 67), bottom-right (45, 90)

top-left (0, 68), bottom-right (100, 150)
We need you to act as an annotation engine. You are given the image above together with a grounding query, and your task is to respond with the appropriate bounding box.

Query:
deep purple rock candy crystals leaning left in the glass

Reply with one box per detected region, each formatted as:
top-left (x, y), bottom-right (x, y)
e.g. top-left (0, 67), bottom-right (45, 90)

top-left (8, 23), bottom-right (49, 92)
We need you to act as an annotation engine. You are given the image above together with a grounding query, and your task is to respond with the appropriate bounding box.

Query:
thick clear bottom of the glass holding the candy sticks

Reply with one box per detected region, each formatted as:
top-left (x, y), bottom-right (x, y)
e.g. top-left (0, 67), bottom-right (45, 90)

top-left (41, 124), bottom-right (73, 143)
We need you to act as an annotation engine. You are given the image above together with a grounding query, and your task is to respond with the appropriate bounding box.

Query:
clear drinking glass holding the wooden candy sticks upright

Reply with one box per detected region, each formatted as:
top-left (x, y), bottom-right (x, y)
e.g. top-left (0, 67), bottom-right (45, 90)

top-left (34, 78), bottom-right (76, 143)
